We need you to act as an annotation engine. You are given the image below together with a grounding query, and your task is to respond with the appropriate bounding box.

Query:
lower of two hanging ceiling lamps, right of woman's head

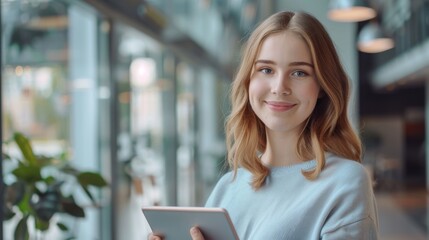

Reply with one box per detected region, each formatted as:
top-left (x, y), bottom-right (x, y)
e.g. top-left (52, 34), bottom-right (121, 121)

top-left (357, 21), bottom-right (395, 53)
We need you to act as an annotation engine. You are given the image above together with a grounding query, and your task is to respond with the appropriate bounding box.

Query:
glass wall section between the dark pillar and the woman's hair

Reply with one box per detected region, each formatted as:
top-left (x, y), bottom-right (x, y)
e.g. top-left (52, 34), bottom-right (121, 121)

top-left (112, 22), bottom-right (228, 239)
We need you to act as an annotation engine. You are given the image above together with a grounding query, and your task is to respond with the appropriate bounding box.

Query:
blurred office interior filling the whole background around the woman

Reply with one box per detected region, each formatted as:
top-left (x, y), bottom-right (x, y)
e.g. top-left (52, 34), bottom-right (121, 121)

top-left (1, 0), bottom-right (429, 240)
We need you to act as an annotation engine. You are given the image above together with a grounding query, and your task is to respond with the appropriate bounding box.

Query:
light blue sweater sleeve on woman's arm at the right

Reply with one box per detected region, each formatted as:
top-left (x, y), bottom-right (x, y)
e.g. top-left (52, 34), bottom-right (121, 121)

top-left (320, 154), bottom-right (378, 234)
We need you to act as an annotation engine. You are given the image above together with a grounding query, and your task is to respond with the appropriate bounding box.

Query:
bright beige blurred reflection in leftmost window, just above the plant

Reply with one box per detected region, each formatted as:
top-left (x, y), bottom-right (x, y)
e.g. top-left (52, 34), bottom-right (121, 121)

top-left (2, 65), bottom-right (70, 140)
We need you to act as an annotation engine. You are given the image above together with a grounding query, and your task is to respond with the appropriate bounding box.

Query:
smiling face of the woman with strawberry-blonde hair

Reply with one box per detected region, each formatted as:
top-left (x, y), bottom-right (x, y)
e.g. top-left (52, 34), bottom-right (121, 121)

top-left (249, 31), bottom-right (320, 134)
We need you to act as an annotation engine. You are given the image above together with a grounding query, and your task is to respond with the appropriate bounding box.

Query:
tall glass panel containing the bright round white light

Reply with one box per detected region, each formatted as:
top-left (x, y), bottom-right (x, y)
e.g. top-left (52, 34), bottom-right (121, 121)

top-left (114, 23), bottom-right (166, 239)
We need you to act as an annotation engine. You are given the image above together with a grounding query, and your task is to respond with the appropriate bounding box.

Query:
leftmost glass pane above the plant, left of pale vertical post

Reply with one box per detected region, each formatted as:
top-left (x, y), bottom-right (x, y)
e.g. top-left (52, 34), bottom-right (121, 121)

top-left (2, 1), bottom-right (70, 141)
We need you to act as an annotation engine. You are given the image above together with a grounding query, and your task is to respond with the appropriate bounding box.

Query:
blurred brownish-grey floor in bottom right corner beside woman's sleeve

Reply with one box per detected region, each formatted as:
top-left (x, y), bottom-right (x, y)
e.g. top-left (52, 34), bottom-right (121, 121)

top-left (376, 189), bottom-right (429, 240)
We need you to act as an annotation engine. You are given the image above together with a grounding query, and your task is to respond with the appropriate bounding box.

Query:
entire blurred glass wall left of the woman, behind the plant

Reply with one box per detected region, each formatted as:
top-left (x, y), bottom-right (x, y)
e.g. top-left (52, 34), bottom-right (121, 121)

top-left (1, 0), bottom-right (265, 239)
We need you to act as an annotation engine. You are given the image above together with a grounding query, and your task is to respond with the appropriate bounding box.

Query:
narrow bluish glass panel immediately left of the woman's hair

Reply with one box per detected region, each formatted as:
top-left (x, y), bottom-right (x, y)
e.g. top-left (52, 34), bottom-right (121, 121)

top-left (196, 68), bottom-right (229, 205)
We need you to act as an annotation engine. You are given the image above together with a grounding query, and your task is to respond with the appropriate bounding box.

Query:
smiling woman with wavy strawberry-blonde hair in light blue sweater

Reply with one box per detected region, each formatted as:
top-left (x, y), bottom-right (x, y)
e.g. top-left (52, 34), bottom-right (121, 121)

top-left (153, 12), bottom-right (378, 240)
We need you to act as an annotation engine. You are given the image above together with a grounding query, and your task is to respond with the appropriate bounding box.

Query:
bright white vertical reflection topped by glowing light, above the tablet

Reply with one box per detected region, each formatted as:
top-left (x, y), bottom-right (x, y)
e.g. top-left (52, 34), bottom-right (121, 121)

top-left (130, 58), bottom-right (163, 205)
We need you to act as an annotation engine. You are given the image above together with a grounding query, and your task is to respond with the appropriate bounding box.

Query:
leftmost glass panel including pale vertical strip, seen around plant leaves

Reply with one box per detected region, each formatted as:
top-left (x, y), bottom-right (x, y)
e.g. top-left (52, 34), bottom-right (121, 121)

top-left (1, 0), bottom-right (106, 239)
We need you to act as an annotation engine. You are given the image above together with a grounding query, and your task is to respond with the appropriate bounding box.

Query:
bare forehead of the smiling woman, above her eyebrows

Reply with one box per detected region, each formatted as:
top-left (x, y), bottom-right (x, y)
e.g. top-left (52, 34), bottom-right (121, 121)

top-left (257, 31), bottom-right (312, 63)
